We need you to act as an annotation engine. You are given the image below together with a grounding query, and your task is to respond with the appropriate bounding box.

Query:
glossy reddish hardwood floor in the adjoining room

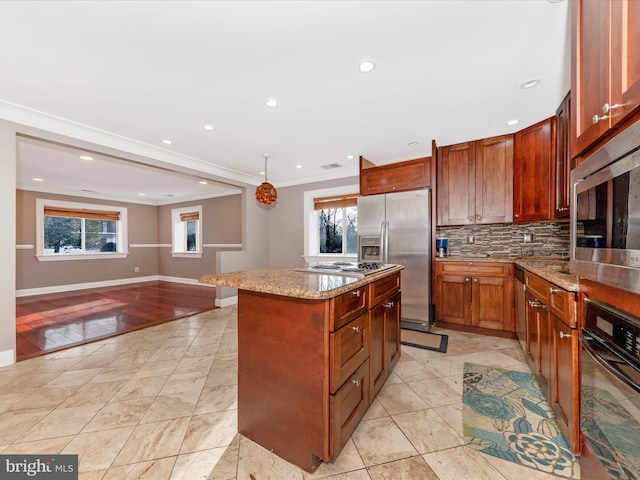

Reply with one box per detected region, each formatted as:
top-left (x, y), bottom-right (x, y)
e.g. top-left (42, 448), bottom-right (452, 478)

top-left (16, 281), bottom-right (216, 360)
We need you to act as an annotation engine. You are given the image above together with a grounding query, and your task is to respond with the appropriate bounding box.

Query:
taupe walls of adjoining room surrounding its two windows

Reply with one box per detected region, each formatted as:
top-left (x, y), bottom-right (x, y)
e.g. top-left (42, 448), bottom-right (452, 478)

top-left (15, 190), bottom-right (242, 290)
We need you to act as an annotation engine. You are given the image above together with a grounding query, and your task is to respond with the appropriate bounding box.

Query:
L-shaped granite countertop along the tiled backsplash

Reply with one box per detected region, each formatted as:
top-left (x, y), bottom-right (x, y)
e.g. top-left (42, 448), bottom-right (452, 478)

top-left (436, 256), bottom-right (578, 292)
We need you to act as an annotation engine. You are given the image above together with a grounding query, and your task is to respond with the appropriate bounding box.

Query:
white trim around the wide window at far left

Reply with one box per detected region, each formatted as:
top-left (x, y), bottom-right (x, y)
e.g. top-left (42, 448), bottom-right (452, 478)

top-left (36, 198), bottom-right (129, 262)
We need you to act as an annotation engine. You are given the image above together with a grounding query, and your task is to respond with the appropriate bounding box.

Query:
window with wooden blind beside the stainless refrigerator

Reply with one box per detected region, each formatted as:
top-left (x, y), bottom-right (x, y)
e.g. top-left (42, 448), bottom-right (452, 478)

top-left (313, 194), bottom-right (358, 254)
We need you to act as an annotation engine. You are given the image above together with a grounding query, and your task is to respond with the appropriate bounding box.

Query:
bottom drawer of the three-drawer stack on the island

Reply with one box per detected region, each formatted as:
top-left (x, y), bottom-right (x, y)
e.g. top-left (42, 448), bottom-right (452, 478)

top-left (329, 360), bottom-right (369, 456)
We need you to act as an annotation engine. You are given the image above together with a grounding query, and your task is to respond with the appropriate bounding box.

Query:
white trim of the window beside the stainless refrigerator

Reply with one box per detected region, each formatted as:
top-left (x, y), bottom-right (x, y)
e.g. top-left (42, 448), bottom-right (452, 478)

top-left (303, 184), bottom-right (360, 262)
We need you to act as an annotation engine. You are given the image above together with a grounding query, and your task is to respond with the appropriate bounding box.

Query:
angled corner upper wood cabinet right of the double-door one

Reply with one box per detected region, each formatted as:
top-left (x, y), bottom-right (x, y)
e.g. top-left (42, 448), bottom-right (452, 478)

top-left (513, 117), bottom-right (555, 222)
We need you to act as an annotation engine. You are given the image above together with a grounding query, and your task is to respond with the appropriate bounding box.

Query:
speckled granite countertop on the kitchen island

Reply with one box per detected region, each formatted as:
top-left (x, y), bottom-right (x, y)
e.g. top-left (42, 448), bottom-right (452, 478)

top-left (199, 265), bottom-right (404, 300)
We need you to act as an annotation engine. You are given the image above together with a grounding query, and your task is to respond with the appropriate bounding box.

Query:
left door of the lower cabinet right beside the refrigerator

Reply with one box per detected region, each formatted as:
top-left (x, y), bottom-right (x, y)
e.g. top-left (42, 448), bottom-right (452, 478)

top-left (435, 275), bottom-right (471, 325)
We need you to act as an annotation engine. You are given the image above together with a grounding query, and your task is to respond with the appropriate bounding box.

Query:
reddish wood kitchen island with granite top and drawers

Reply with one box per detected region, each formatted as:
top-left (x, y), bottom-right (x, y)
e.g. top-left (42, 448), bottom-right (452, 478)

top-left (200, 265), bottom-right (403, 472)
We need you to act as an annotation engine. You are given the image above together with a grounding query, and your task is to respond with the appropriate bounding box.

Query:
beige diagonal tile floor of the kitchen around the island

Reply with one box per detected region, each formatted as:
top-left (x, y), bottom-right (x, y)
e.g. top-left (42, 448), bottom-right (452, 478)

top-left (0, 307), bottom-right (579, 480)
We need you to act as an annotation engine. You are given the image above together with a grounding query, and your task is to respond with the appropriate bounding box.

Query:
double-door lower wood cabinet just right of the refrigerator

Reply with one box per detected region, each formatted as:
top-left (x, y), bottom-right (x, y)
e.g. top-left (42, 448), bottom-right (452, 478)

top-left (435, 261), bottom-right (515, 333)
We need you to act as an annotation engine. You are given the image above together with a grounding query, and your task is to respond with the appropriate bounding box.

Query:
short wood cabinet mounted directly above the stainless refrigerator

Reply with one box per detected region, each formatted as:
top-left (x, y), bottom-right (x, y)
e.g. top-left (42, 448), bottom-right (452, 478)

top-left (360, 157), bottom-right (431, 195)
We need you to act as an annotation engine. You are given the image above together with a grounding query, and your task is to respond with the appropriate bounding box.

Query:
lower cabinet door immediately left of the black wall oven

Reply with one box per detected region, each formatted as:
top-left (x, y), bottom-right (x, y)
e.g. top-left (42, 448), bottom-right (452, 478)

top-left (549, 315), bottom-right (578, 451)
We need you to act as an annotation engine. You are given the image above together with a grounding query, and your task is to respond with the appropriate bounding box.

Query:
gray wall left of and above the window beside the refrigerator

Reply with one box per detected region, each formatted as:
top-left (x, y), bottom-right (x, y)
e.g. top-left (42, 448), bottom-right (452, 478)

top-left (269, 177), bottom-right (359, 266)
